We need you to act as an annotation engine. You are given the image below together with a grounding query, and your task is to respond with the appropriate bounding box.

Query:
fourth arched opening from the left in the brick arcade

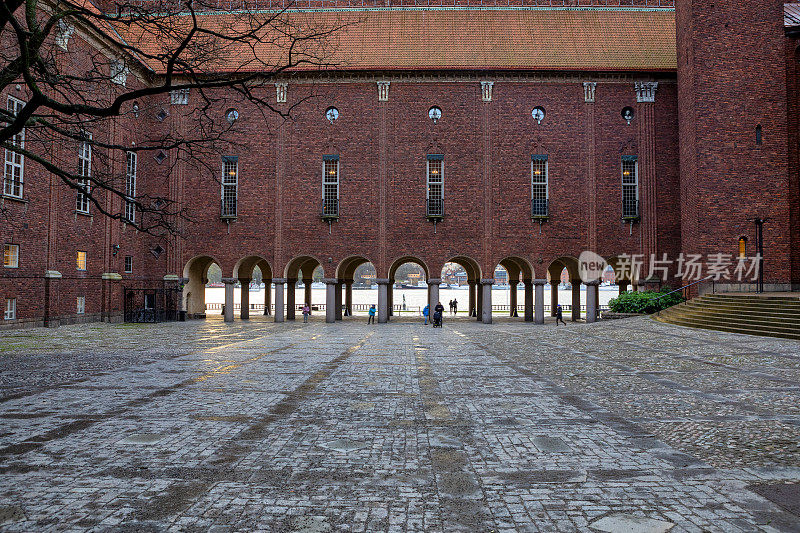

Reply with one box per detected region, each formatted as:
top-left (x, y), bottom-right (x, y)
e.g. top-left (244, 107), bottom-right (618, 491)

top-left (334, 256), bottom-right (378, 320)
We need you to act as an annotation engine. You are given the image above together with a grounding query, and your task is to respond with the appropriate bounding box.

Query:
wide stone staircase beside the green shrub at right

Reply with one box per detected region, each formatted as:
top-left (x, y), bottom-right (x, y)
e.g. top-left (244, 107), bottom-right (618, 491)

top-left (653, 294), bottom-right (800, 340)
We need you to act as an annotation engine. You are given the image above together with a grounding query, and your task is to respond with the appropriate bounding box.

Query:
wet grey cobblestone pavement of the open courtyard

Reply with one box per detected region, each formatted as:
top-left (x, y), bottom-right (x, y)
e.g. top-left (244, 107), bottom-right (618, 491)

top-left (0, 319), bottom-right (800, 532)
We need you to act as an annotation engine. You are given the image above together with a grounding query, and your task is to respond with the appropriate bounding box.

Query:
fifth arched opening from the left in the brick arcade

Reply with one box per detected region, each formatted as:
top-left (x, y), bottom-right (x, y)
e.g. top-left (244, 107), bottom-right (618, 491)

top-left (387, 256), bottom-right (430, 316)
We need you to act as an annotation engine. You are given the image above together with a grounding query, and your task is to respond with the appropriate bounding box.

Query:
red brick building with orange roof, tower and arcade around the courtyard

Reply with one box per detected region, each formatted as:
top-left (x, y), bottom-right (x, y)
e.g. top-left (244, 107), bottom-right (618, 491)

top-left (0, 0), bottom-right (800, 327)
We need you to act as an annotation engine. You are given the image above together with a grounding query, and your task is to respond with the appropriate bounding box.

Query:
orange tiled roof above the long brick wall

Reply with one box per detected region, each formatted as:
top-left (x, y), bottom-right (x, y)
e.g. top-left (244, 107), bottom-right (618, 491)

top-left (120, 9), bottom-right (677, 72)
